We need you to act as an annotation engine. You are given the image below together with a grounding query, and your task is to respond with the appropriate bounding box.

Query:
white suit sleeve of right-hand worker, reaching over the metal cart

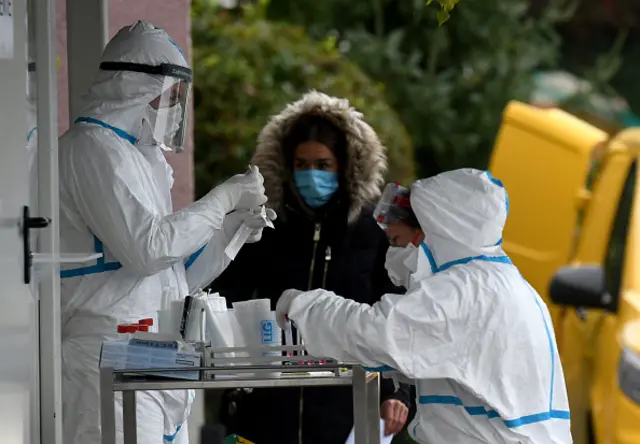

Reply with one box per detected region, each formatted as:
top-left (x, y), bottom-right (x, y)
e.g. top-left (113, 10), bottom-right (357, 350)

top-left (289, 273), bottom-right (482, 379)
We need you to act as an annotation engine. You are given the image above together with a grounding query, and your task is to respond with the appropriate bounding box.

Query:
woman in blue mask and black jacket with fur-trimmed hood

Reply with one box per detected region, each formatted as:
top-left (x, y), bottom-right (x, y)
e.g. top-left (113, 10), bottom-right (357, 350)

top-left (211, 92), bottom-right (409, 444)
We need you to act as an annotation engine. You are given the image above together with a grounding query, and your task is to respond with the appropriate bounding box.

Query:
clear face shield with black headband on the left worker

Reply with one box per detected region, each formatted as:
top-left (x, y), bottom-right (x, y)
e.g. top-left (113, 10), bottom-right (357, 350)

top-left (100, 62), bottom-right (192, 153)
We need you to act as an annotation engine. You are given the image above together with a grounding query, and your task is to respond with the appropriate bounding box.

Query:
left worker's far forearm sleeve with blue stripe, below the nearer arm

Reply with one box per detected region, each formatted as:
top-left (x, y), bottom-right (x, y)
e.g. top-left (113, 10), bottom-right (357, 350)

top-left (184, 230), bottom-right (231, 294)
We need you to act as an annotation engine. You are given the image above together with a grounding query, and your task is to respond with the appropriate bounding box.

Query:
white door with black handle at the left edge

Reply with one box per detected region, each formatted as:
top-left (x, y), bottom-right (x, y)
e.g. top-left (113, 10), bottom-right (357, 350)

top-left (0, 0), bottom-right (39, 444)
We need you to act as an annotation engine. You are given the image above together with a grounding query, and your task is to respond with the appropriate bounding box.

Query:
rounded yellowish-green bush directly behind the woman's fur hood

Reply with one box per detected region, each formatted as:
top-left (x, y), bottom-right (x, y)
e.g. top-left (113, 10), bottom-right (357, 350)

top-left (192, 0), bottom-right (414, 195)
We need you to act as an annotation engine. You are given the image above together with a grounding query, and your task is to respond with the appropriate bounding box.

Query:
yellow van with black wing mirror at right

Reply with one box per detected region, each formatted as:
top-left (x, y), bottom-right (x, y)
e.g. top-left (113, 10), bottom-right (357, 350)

top-left (490, 102), bottom-right (640, 444)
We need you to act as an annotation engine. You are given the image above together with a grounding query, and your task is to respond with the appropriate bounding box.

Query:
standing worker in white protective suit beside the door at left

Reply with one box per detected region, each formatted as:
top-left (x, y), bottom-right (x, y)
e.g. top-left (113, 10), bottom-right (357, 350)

top-left (59, 22), bottom-right (274, 444)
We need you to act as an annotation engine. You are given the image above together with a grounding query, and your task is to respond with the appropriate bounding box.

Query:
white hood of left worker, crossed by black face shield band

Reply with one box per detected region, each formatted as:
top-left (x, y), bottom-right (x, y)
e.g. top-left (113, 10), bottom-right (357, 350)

top-left (80, 21), bottom-right (188, 139)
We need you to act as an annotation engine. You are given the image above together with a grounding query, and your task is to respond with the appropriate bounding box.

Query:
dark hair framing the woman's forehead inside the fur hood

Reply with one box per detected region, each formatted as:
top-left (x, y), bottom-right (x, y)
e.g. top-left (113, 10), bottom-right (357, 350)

top-left (282, 114), bottom-right (347, 170)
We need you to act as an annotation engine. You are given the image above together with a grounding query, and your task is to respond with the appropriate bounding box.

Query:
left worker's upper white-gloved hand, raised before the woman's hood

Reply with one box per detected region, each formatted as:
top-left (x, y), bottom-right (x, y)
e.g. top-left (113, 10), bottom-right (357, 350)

top-left (209, 166), bottom-right (267, 213)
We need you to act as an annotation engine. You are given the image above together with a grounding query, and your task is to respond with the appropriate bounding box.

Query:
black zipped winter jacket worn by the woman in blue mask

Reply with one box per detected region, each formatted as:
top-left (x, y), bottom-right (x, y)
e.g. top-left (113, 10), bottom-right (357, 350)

top-left (211, 203), bottom-right (409, 444)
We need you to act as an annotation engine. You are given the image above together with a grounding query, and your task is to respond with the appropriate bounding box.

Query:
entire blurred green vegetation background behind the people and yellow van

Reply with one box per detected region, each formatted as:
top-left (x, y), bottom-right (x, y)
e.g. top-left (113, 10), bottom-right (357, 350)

top-left (192, 0), bottom-right (640, 441)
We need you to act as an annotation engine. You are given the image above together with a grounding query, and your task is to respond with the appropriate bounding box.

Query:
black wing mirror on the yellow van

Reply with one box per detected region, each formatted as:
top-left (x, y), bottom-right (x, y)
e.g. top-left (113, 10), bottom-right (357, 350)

top-left (549, 265), bottom-right (615, 311)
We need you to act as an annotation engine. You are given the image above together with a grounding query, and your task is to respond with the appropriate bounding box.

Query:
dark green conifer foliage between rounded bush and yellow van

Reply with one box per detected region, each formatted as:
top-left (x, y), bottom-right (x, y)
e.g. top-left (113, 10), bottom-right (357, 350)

top-left (269, 0), bottom-right (574, 176)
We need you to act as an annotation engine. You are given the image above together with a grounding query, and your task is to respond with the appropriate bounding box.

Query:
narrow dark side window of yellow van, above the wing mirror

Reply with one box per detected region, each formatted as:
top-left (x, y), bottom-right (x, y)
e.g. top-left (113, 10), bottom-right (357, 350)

top-left (604, 162), bottom-right (636, 305)
